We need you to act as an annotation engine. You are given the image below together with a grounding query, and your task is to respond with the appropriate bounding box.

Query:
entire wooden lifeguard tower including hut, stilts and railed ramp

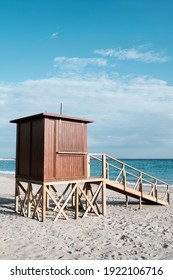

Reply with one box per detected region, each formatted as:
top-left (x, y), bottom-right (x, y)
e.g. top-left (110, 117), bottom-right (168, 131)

top-left (11, 113), bottom-right (170, 221)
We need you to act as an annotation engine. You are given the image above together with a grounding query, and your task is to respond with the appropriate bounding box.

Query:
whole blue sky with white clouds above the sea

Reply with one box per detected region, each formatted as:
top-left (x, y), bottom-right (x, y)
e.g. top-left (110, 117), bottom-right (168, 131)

top-left (0, 0), bottom-right (173, 158)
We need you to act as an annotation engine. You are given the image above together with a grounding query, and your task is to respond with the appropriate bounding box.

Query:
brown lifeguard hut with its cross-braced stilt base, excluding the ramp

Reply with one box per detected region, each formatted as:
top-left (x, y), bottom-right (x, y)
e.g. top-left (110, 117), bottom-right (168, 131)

top-left (11, 113), bottom-right (105, 221)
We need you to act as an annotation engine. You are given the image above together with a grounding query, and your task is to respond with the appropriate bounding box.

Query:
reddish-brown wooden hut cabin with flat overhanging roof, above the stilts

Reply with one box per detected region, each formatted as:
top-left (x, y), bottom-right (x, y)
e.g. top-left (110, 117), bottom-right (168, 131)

top-left (11, 113), bottom-right (92, 182)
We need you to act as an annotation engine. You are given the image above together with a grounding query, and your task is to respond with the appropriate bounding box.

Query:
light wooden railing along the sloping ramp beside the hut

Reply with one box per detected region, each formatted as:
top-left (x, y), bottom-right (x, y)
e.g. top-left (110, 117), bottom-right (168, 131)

top-left (88, 154), bottom-right (170, 203)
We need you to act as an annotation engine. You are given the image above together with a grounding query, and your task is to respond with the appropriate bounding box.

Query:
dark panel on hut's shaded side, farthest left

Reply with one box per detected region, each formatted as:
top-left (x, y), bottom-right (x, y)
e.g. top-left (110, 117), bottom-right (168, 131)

top-left (16, 121), bottom-right (31, 177)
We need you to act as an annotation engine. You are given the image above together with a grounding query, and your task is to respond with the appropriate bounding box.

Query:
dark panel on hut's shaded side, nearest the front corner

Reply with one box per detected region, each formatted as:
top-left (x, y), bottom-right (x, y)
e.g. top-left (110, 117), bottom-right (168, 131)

top-left (30, 119), bottom-right (44, 180)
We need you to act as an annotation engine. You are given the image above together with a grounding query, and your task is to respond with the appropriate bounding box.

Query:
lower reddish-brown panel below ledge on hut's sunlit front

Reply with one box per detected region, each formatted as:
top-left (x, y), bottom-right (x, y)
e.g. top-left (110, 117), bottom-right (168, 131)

top-left (56, 154), bottom-right (87, 180)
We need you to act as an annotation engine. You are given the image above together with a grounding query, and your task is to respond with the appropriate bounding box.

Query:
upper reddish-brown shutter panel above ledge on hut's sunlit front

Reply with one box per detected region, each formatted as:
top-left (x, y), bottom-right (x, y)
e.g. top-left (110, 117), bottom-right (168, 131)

top-left (57, 121), bottom-right (87, 152)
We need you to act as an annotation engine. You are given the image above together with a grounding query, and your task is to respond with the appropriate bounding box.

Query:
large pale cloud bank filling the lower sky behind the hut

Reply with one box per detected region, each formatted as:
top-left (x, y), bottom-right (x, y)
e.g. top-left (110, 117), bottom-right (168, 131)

top-left (0, 72), bottom-right (173, 157)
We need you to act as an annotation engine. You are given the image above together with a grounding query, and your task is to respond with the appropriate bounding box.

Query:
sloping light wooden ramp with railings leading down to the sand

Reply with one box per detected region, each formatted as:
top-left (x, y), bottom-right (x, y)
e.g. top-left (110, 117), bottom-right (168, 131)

top-left (89, 154), bottom-right (170, 207)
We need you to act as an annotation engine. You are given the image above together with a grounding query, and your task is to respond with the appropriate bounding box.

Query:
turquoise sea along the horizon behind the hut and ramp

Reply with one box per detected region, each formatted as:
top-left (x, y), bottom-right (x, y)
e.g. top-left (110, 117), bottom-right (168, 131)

top-left (0, 159), bottom-right (173, 185)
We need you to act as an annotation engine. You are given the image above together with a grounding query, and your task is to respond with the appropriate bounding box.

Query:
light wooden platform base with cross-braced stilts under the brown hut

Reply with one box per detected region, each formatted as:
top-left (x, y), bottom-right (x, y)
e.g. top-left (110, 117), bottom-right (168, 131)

top-left (15, 178), bottom-right (106, 222)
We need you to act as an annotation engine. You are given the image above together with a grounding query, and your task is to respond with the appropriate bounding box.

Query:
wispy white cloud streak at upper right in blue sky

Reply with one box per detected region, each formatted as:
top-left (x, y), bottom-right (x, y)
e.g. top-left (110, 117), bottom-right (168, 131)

top-left (95, 47), bottom-right (169, 63)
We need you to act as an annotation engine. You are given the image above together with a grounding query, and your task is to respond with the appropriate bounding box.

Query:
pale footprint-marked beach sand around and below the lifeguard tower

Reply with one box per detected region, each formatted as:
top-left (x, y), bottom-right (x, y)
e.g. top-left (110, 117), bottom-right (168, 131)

top-left (0, 176), bottom-right (173, 260)
